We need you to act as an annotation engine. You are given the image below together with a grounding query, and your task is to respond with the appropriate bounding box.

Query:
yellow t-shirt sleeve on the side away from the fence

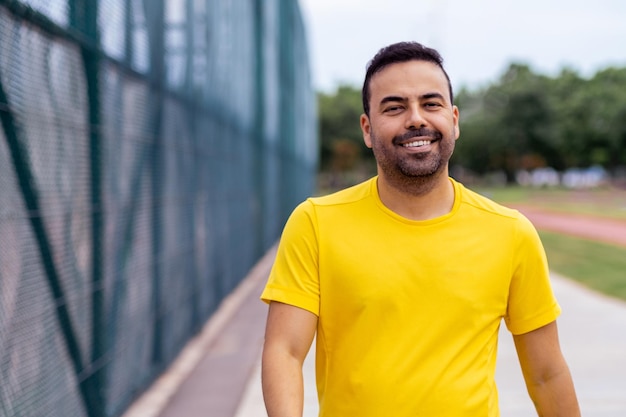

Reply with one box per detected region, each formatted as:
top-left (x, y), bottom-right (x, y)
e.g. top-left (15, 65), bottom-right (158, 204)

top-left (504, 214), bottom-right (561, 334)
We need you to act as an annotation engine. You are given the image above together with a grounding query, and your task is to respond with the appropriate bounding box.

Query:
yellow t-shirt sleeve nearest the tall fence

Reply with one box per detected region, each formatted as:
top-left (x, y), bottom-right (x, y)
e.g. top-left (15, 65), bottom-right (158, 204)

top-left (261, 200), bottom-right (320, 315)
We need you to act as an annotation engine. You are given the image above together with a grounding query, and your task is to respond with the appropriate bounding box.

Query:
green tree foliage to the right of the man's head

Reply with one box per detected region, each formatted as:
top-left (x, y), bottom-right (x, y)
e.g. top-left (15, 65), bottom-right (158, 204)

top-left (453, 63), bottom-right (626, 180)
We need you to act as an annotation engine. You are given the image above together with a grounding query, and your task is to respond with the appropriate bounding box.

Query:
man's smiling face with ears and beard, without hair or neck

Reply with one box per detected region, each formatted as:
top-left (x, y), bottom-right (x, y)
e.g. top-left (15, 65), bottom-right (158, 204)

top-left (361, 60), bottom-right (459, 181)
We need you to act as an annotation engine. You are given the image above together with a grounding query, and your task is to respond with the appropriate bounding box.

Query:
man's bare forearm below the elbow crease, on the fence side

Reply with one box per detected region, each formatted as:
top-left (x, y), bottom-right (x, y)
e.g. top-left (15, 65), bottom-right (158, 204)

top-left (261, 349), bottom-right (304, 417)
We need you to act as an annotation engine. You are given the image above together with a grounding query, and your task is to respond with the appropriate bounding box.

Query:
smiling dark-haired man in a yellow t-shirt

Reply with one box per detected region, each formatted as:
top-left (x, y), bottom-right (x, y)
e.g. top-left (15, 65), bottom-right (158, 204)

top-left (261, 42), bottom-right (580, 417)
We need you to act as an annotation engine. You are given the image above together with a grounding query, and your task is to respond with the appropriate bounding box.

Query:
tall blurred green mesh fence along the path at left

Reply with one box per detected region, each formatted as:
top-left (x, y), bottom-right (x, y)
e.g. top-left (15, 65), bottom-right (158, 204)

top-left (0, 0), bottom-right (317, 417)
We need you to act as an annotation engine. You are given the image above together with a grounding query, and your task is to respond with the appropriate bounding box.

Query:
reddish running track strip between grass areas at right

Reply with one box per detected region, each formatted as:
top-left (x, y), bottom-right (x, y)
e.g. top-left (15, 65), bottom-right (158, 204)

top-left (515, 206), bottom-right (626, 248)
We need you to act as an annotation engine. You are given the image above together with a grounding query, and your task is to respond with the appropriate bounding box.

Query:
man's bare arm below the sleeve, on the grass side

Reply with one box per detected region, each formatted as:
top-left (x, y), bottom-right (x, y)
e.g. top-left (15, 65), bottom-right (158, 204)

top-left (513, 321), bottom-right (580, 417)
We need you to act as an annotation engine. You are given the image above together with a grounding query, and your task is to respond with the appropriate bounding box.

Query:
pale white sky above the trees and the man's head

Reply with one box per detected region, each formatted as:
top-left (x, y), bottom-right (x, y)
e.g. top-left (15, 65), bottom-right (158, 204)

top-left (300, 0), bottom-right (626, 91)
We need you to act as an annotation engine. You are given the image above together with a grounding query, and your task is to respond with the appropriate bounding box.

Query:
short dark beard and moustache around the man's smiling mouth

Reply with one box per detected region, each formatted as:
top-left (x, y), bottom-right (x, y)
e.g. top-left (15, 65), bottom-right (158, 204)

top-left (370, 128), bottom-right (455, 194)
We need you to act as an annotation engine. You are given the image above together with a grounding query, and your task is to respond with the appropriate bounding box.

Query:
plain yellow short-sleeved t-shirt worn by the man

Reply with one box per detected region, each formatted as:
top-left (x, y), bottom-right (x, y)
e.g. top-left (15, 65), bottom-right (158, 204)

top-left (261, 178), bottom-right (560, 417)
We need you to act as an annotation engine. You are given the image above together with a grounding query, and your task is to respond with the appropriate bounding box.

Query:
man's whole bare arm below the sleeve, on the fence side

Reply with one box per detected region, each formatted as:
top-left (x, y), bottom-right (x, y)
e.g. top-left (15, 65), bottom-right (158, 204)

top-left (261, 302), bottom-right (317, 417)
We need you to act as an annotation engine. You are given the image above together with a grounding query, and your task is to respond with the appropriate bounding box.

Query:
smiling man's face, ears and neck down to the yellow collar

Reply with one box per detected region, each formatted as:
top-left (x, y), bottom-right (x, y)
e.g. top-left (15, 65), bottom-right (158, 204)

top-left (361, 60), bottom-right (459, 220)
